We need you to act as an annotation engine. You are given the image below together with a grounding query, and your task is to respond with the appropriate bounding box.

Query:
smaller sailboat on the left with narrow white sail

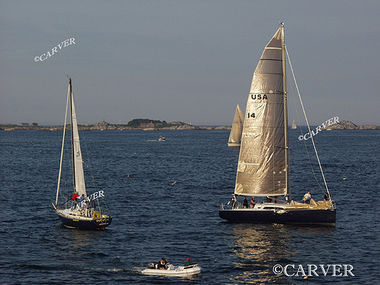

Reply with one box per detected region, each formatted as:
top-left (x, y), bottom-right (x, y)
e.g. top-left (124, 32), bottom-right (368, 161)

top-left (52, 78), bottom-right (112, 230)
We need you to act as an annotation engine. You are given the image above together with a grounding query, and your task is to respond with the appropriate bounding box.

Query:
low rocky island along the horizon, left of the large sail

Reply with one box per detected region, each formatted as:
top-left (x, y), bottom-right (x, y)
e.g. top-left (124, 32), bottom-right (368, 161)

top-left (0, 119), bottom-right (231, 131)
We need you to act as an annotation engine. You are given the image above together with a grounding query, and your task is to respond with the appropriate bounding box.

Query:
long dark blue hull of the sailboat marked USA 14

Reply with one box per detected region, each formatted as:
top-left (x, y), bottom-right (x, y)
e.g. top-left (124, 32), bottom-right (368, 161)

top-left (219, 206), bottom-right (336, 224)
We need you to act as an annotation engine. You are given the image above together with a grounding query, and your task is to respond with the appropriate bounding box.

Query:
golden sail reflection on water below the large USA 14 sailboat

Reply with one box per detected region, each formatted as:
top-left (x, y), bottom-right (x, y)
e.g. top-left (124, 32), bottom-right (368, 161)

top-left (230, 224), bottom-right (335, 284)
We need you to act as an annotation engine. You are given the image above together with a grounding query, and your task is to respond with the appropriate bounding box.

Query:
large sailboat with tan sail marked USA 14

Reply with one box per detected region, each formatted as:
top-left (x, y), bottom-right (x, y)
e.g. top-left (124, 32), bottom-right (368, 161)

top-left (219, 23), bottom-right (336, 224)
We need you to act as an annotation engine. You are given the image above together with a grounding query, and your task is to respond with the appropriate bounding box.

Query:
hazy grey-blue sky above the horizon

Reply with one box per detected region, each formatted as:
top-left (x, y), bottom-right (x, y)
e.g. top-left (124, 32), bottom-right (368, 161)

top-left (0, 0), bottom-right (380, 125)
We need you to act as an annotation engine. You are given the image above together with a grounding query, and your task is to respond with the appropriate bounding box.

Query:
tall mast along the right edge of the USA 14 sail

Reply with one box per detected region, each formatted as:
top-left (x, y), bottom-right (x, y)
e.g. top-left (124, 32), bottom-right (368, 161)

top-left (281, 22), bottom-right (290, 201)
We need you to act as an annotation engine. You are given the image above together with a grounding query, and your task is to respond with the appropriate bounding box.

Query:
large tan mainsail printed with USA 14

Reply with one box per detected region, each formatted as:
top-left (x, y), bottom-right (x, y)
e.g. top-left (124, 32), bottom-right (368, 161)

top-left (235, 25), bottom-right (288, 196)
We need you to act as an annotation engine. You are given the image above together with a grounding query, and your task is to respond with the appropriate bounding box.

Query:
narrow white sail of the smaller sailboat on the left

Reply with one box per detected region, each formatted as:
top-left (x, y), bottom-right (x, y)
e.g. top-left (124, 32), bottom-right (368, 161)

top-left (69, 79), bottom-right (86, 196)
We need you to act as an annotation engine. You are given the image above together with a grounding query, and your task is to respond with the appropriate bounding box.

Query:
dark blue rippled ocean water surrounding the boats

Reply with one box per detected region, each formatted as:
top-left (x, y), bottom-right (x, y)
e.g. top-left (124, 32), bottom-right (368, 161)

top-left (0, 130), bottom-right (380, 284)
